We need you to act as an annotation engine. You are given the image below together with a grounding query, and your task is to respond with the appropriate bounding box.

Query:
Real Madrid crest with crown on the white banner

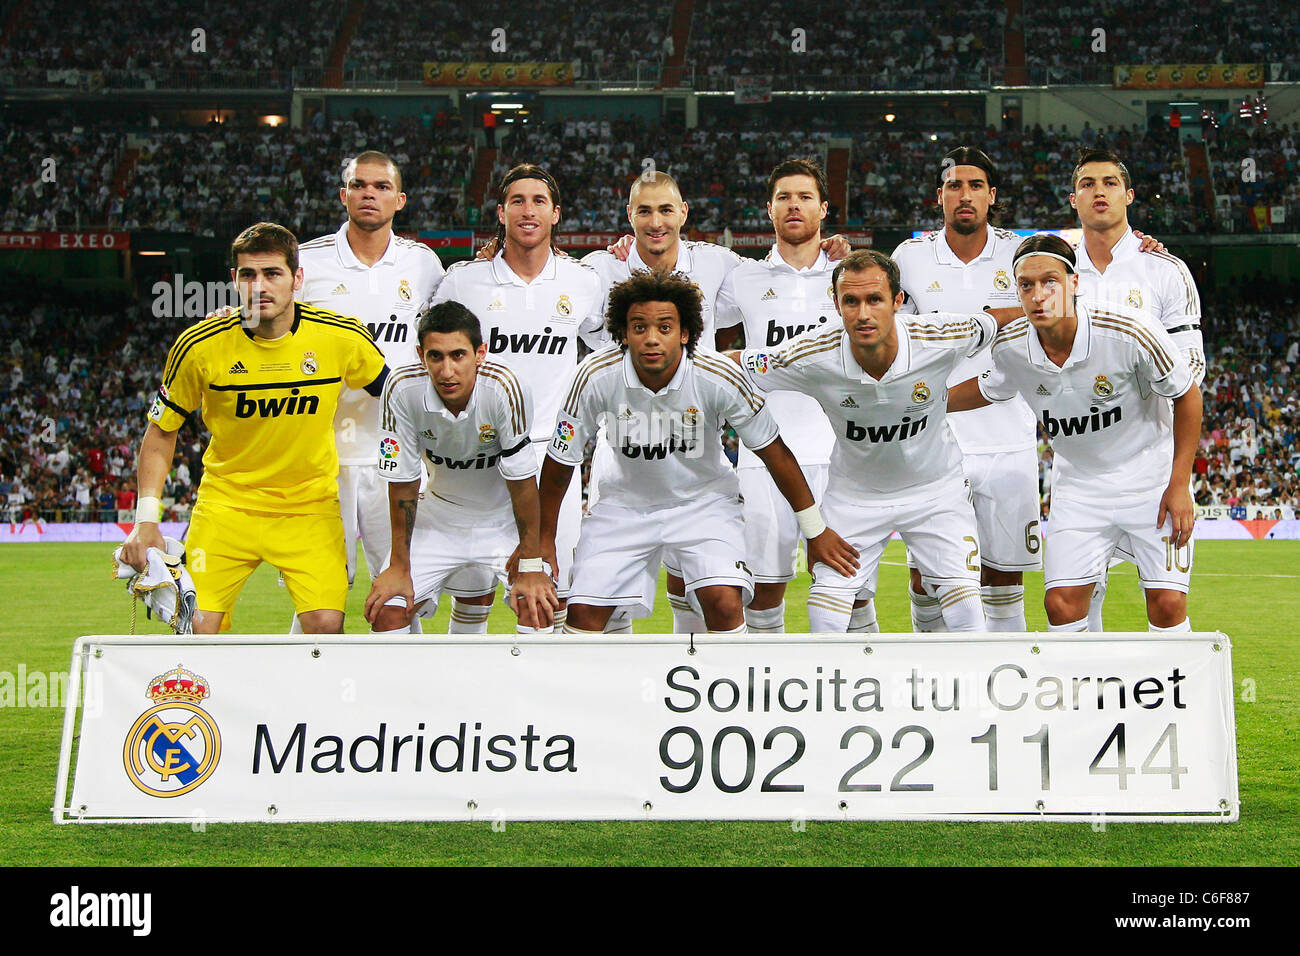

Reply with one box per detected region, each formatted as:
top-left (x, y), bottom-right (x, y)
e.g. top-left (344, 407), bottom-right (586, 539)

top-left (122, 665), bottom-right (221, 797)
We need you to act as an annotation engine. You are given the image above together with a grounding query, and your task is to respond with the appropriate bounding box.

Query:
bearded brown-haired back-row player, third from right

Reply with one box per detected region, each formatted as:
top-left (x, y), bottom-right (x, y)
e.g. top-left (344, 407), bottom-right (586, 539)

top-left (712, 159), bottom-right (863, 632)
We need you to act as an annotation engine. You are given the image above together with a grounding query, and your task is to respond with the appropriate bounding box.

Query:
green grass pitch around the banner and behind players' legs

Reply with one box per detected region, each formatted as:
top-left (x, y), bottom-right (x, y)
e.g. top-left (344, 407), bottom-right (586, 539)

top-left (0, 541), bottom-right (1300, 866)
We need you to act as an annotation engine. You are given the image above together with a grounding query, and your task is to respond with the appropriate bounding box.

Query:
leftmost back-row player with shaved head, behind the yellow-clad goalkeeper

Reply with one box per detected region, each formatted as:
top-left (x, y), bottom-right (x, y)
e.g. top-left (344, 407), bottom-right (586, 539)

top-left (299, 150), bottom-right (443, 613)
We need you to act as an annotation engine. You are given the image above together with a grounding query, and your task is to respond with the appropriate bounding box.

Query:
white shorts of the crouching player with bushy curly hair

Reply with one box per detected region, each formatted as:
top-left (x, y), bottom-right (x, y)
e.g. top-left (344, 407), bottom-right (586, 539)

top-left (569, 496), bottom-right (754, 618)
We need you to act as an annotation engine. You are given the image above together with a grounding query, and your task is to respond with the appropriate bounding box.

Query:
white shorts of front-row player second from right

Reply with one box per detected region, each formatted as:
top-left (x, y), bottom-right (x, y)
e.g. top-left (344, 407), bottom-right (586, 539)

top-left (813, 479), bottom-right (980, 598)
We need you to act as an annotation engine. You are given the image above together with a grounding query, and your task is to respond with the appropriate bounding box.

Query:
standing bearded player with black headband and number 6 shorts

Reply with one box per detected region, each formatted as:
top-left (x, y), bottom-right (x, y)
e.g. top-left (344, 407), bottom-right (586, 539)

top-left (893, 146), bottom-right (1041, 631)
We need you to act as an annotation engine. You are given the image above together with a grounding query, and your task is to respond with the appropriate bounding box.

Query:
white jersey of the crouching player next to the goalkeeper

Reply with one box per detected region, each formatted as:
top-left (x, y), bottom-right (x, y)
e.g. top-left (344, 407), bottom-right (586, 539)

top-left (378, 362), bottom-right (537, 523)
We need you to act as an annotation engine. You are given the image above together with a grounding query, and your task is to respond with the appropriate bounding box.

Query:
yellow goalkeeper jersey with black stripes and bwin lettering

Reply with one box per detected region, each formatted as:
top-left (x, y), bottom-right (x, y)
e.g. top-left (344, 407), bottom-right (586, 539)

top-left (148, 302), bottom-right (387, 514)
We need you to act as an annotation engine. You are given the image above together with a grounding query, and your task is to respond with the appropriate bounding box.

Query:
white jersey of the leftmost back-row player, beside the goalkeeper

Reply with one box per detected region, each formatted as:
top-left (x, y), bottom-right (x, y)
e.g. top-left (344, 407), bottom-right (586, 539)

top-left (298, 222), bottom-right (443, 464)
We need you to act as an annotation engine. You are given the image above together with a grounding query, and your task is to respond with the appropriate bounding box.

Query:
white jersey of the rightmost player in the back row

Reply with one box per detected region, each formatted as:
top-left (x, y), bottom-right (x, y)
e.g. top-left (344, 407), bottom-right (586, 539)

top-left (1075, 229), bottom-right (1205, 384)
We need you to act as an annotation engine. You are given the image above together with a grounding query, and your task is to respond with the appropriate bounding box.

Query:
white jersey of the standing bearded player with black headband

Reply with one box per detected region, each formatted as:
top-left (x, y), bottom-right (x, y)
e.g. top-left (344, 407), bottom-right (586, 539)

top-left (893, 226), bottom-right (1036, 455)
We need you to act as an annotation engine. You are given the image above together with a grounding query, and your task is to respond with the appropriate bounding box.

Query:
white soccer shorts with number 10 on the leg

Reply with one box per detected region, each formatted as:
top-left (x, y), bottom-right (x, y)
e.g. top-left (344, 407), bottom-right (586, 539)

top-left (1044, 489), bottom-right (1196, 594)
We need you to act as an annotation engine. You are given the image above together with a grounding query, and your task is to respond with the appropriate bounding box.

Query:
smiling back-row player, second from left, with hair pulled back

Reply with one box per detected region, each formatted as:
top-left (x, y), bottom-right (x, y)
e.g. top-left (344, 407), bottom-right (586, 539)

top-left (433, 164), bottom-right (605, 633)
